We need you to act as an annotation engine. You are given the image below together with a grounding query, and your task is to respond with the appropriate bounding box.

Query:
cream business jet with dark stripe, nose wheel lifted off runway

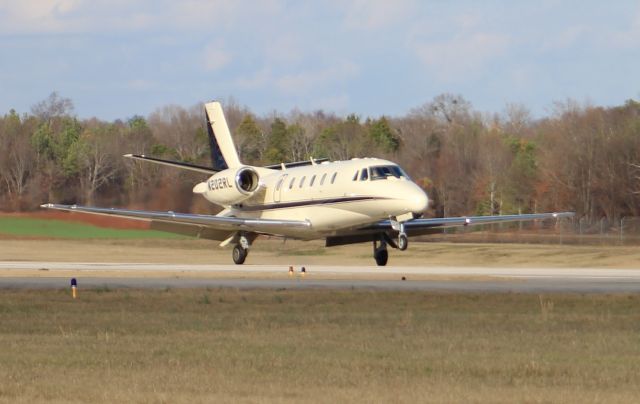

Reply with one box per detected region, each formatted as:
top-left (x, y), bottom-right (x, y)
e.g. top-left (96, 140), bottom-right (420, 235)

top-left (42, 102), bottom-right (573, 265)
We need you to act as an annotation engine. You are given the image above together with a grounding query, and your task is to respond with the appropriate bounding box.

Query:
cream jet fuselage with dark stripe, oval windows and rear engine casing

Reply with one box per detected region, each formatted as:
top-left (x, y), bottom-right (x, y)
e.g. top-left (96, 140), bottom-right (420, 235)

top-left (194, 158), bottom-right (428, 239)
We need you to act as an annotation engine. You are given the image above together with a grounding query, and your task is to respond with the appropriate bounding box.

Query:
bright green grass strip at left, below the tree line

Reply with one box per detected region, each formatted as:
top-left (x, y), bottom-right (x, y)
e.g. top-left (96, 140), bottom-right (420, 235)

top-left (0, 217), bottom-right (185, 239)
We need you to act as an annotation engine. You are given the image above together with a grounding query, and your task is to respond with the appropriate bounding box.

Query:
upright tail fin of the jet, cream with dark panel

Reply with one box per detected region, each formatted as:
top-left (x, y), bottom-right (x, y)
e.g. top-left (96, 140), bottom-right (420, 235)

top-left (204, 101), bottom-right (242, 170)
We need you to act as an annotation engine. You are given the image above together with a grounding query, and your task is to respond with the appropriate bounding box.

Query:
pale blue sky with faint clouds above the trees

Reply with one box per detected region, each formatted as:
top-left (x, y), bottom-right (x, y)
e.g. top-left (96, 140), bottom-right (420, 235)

top-left (0, 0), bottom-right (640, 120)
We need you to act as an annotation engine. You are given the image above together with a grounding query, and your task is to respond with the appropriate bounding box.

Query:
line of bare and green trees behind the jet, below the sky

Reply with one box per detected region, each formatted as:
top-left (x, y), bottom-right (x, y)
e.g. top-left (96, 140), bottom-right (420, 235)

top-left (0, 93), bottom-right (640, 220)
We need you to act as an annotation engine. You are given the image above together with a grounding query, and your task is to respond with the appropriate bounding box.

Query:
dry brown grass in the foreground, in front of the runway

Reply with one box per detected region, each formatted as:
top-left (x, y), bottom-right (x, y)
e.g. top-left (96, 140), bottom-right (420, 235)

top-left (0, 289), bottom-right (640, 402)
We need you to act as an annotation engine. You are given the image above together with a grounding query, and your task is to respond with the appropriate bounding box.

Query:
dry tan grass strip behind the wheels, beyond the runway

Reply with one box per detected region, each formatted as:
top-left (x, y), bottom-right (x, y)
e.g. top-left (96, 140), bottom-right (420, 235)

top-left (0, 239), bottom-right (640, 268)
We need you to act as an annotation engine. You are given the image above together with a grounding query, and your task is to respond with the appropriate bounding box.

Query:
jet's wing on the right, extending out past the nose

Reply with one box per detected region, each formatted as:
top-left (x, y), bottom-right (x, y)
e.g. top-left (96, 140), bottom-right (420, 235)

top-left (362, 212), bottom-right (575, 236)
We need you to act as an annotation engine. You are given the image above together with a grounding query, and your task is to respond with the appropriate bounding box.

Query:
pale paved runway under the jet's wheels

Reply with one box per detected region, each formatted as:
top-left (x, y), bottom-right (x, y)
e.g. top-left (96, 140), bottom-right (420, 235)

top-left (0, 262), bottom-right (640, 293)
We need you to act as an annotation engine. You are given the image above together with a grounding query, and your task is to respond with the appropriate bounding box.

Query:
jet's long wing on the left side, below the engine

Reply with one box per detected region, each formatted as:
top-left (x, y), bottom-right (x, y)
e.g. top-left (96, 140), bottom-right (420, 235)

top-left (40, 203), bottom-right (311, 240)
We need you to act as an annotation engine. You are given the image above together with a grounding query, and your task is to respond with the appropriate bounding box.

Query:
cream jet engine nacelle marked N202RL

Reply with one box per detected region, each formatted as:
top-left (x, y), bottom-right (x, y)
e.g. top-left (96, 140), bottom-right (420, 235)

top-left (193, 167), bottom-right (260, 206)
